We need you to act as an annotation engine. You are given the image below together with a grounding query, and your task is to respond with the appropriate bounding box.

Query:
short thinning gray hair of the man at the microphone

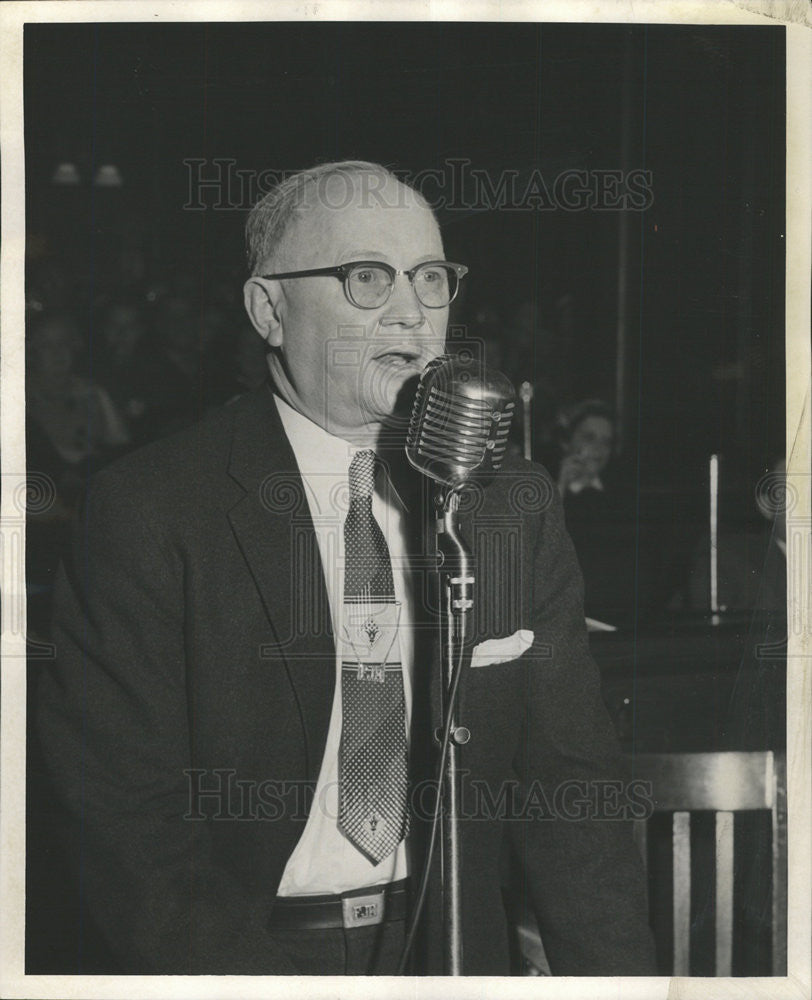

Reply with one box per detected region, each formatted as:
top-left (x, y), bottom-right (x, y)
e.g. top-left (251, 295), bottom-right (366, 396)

top-left (245, 160), bottom-right (427, 274)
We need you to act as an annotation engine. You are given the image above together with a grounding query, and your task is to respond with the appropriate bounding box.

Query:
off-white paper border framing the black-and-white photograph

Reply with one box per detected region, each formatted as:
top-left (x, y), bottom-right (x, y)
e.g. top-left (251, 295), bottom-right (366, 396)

top-left (0, 0), bottom-right (812, 1000)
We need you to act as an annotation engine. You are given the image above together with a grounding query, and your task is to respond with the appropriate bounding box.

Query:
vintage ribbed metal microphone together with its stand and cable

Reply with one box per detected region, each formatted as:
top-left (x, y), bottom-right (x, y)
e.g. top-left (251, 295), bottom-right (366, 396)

top-left (399, 354), bottom-right (516, 976)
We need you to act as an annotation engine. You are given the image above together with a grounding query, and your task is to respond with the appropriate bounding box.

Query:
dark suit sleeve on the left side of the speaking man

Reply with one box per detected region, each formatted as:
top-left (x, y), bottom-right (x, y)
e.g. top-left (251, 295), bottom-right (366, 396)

top-left (38, 473), bottom-right (296, 975)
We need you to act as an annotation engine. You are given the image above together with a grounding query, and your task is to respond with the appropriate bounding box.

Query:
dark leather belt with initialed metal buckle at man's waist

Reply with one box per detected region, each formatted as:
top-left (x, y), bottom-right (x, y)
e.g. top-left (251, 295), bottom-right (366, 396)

top-left (268, 878), bottom-right (410, 931)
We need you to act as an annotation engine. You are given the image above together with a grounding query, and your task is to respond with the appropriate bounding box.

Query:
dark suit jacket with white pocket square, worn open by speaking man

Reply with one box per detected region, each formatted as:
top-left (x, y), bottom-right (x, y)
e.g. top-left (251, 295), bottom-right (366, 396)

top-left (39, 387), bottom-right (653, 975)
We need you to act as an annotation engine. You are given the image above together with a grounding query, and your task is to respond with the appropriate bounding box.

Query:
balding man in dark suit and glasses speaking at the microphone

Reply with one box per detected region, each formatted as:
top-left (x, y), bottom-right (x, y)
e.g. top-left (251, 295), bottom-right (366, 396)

top-left (40, 162), bottom-right (653, 975)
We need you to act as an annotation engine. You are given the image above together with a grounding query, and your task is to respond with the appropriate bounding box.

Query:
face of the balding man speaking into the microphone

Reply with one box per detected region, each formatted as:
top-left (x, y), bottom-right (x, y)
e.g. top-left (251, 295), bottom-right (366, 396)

top-left (254, 178), bottom-right (448, 440)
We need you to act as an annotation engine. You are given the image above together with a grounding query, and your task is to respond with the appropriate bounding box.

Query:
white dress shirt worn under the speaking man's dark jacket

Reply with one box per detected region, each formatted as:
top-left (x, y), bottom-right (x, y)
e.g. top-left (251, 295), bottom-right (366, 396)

top-left (274, 396), bottom-right (414, 896)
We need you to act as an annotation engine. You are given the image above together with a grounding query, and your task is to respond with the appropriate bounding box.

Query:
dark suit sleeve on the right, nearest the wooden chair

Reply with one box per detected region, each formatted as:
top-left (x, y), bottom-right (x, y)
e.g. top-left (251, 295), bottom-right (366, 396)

top-left (509, 480), bottom-right (656, 976)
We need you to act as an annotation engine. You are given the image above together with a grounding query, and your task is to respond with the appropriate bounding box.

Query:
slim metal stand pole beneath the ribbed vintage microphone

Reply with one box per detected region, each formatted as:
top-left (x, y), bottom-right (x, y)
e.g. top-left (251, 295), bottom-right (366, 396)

top-left (435, 489), bottom-right (474, 976)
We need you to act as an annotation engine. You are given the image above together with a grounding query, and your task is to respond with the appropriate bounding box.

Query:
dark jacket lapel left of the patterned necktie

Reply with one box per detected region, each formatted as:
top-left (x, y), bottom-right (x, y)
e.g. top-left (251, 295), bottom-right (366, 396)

top-left (228, 386), bottom-right (335, 781)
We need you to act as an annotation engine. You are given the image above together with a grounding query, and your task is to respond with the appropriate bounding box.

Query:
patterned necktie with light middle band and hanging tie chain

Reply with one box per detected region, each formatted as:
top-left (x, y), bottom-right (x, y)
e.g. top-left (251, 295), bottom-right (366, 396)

top-left (338, 451), bottom-right (409, 864)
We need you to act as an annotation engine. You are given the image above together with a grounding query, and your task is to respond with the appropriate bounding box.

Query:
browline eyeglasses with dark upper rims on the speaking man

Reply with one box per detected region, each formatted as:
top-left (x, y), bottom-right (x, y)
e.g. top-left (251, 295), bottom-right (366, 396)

top-left (262, 260), bottom-right (468, 309)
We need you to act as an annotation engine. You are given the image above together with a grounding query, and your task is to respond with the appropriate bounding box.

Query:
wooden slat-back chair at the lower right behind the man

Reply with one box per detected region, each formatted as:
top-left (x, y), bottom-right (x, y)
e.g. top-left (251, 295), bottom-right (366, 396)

top-left (631, 751), bottom-right (787, 976)
